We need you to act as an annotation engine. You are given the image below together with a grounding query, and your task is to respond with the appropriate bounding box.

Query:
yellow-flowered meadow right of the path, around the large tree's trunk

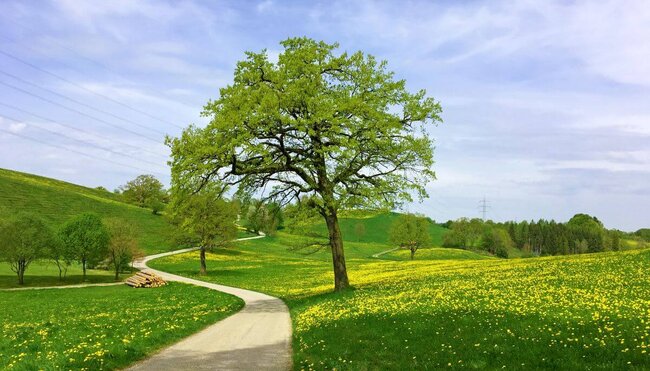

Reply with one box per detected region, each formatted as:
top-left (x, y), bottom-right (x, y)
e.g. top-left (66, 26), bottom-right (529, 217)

top-left (151, 235), bottom-right (650, 370)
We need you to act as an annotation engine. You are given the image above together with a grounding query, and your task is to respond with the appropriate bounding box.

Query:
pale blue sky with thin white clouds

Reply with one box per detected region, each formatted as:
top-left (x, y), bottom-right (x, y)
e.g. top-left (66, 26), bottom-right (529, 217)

top-left (0, 0), bottom-right (650, 230)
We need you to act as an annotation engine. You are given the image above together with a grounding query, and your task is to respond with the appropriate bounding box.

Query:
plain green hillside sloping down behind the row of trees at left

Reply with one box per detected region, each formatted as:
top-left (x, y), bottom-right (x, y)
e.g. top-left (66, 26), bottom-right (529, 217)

top-left (0, 169), bottom-right (171, 256)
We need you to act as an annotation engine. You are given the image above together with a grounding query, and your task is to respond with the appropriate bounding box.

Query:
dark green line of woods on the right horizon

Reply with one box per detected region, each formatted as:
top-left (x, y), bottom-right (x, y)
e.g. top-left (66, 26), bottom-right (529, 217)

top-left (441, 214), bottom-right (650, 257)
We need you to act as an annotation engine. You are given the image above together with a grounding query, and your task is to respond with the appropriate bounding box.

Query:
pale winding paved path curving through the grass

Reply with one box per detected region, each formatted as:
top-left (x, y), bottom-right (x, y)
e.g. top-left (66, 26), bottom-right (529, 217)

top-left (128, 236), bottom-right (292, 370)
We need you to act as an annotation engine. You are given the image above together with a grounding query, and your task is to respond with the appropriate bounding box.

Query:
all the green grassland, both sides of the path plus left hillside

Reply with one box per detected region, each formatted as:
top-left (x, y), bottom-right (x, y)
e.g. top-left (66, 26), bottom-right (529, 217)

top-left (0, 171), bottom-right (650, 370)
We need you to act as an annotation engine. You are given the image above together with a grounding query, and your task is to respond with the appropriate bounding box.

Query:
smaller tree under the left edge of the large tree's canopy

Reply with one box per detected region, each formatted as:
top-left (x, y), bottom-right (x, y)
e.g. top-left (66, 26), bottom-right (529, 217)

top-left (171, 186), bottom-right (238, 274)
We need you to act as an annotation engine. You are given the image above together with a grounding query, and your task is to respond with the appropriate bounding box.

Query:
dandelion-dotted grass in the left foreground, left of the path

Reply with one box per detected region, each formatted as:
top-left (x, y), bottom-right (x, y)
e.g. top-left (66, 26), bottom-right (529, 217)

top-left (0, 283), bottom-right (243, 370)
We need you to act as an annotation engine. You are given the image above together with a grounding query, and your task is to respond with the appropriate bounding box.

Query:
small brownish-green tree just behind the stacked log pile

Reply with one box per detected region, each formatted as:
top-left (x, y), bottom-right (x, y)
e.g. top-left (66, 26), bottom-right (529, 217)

top-left (106, 219), bottom-right (141, 281)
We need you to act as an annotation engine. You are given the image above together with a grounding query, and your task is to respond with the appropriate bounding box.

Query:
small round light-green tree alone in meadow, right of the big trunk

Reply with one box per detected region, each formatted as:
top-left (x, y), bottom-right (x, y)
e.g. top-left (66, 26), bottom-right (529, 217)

top-left (389, 214), bottom-right (431, 260)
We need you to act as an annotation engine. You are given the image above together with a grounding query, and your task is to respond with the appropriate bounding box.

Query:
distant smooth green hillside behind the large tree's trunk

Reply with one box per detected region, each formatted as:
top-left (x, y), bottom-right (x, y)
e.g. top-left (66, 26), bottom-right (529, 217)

top-left (296, 212), bottom-right (447, 246)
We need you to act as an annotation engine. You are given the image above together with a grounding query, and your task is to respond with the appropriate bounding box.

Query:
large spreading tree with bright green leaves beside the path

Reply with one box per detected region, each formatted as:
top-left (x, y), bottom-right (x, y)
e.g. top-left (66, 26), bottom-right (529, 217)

top-left (168, 38), bottom-right (441, 290)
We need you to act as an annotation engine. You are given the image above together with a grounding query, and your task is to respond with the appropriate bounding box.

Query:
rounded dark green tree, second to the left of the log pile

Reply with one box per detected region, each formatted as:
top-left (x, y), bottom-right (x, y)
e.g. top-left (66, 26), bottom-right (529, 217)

top-left (59, 213), bottom-right (110, 281)
